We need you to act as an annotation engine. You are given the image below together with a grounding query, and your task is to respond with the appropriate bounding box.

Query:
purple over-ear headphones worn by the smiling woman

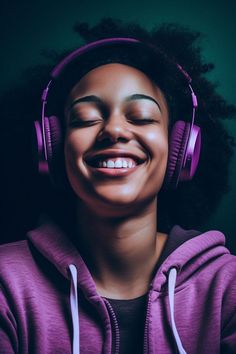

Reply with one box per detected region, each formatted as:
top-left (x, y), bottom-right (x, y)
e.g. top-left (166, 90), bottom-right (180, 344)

top-left (34, 38), bottom-right (201, 188)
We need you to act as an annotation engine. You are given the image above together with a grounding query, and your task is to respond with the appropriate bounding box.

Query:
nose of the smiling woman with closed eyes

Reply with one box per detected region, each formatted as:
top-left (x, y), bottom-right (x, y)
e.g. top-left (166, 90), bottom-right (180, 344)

top-left (97, 114), bottom-right (133, 143)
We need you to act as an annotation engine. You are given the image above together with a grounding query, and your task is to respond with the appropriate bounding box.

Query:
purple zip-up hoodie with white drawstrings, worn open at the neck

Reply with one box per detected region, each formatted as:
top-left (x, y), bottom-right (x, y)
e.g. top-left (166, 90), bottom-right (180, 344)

top-left (0, 217), bottom-right (236, 354)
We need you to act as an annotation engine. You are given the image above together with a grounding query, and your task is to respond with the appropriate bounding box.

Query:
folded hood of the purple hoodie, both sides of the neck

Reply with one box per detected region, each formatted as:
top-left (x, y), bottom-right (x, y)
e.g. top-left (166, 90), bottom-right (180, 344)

top-left (27, 216), bottom-right (229, 297)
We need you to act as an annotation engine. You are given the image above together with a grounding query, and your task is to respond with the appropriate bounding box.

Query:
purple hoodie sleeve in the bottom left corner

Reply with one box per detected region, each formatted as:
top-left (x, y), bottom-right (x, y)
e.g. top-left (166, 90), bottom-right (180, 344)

top-left (0, 285), bottom-right (18, 354)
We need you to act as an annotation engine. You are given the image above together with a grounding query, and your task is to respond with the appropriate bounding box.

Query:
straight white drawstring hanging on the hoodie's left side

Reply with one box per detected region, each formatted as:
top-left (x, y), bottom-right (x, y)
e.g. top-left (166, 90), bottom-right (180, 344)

top-left (69, 264), bottom-right (80, 354)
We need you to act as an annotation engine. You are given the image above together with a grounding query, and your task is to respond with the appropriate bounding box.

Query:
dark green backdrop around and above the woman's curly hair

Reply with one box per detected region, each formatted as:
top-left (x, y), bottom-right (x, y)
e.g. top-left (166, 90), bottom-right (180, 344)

top-left (0, 0), bottom-right (236, 254)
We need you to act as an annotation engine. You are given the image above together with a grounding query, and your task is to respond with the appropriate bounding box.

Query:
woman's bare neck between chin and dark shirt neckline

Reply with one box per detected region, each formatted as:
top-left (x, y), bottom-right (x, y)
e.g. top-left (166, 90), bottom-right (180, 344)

top-left (74, 201), bottom-right (166, 299)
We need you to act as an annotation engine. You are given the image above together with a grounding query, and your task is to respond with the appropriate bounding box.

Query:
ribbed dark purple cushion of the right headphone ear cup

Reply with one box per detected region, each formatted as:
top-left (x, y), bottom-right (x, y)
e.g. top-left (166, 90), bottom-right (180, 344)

top-left (165, 120), bottom-right (191, 188)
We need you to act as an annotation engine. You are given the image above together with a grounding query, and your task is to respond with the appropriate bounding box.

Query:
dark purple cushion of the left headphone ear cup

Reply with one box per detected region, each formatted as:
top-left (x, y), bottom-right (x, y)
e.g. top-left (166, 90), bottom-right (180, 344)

top-left (44, 116), bottom-right (64, 185)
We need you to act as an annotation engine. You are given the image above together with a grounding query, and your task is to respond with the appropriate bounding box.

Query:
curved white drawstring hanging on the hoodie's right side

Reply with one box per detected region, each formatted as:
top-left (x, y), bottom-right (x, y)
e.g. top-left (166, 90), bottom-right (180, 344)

top-left (168, 268), bottom-right (187, 354)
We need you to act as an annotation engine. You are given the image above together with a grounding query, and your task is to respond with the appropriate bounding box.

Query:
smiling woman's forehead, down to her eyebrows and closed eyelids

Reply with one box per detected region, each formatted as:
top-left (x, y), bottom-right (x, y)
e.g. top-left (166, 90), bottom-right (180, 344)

top-left (64, 63), bottom-right (169, 127)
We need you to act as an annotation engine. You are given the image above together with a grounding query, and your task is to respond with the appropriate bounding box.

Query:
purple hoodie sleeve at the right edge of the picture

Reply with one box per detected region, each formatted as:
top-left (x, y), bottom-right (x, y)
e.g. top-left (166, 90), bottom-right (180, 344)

top-left (221, 257), bottom-right (236, 354)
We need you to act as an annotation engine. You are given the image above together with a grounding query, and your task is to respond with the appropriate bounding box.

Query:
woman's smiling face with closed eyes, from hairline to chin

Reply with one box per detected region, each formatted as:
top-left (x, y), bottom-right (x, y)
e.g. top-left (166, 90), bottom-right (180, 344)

top-left (64, 63), bottom-right (168, 215)
